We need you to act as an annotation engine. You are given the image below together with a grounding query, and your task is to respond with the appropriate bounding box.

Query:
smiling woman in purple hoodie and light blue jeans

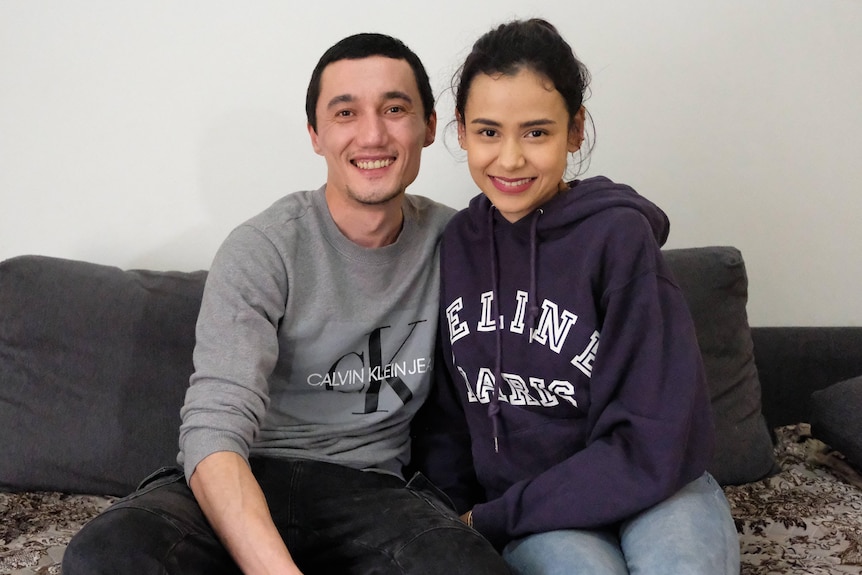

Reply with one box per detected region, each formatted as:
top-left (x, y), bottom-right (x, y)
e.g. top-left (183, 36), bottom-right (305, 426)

top-left (418, 19), bottom-right (739, 575)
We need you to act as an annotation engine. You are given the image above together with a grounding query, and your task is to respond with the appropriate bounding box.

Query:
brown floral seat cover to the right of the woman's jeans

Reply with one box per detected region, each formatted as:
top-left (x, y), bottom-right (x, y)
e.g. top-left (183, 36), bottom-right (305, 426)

top-left (725, 423), bottom-right (862, 575)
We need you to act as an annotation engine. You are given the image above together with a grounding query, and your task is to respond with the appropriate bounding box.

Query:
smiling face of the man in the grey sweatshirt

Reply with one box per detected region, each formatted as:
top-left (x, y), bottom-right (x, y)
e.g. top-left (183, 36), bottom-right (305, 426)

top-left (308, 56), bottom-right (437, 205)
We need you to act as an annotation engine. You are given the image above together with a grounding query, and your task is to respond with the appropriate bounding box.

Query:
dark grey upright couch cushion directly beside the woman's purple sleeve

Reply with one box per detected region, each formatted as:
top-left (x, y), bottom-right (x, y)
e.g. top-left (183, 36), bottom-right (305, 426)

top-left (664, 247), bottom-right (776, 485)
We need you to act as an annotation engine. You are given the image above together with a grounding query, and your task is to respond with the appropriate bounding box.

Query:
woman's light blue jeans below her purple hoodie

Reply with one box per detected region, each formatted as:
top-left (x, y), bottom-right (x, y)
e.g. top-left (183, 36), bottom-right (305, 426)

top-left (503, 473), bottom-right (739, 575)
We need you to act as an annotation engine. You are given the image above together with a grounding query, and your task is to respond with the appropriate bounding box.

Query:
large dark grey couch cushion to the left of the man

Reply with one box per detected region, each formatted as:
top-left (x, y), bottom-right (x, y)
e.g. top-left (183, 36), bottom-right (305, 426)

top-left (0, 256), bottom-right (206, 495)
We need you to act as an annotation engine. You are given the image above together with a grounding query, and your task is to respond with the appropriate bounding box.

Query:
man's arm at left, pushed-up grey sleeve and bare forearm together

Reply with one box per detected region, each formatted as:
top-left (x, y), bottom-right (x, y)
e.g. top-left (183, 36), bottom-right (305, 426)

top-left (178, 225), bottom-right (300, 575)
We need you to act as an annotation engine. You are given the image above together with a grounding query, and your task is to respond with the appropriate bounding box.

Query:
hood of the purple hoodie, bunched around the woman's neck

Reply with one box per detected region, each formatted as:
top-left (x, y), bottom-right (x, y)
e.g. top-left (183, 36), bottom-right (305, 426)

top-left (468, 176), bottom-right (670, 245)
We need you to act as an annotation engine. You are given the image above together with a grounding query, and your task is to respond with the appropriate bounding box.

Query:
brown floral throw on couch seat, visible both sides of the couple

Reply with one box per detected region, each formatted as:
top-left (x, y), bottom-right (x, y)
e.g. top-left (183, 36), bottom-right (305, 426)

top-left (0, 424), bottom-right (862, 575)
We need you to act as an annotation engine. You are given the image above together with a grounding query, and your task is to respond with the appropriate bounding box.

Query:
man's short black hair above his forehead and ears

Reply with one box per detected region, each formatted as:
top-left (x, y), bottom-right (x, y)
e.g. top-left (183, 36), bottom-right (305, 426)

top-left (305, 32), bottom-right (434, 132)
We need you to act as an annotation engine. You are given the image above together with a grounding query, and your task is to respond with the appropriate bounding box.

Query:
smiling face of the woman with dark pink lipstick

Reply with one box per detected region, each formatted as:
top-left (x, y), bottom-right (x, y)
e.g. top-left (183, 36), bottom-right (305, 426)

top-left (458, 69), bottom-right (584, 222)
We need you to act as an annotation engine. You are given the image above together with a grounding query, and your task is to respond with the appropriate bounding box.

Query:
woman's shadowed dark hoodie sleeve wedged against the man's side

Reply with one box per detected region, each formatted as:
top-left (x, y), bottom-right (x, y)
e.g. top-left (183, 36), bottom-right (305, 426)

top-left (408, 333), bottom-right (483, 515)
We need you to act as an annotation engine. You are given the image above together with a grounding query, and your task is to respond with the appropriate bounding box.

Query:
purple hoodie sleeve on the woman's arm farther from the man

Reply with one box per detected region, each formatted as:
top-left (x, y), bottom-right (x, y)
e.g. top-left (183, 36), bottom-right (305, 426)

top-left (473, 215), bottom-right (713, 548)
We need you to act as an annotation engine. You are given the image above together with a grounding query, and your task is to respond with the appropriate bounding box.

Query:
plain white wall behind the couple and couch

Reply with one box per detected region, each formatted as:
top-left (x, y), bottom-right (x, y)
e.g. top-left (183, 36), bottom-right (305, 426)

top-left (0, 0), bottom-right (862, 325)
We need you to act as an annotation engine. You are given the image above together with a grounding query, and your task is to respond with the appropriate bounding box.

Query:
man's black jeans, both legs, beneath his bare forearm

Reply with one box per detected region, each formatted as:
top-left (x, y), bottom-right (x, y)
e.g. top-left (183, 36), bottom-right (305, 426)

top-left (63, 458), bottom-right (508, 575)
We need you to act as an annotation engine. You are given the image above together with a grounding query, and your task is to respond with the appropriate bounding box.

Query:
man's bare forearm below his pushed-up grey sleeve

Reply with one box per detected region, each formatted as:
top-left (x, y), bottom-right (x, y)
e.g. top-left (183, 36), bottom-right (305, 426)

top-left (189, 451), bottom-right (302, 575)
